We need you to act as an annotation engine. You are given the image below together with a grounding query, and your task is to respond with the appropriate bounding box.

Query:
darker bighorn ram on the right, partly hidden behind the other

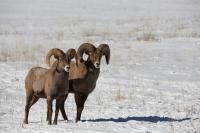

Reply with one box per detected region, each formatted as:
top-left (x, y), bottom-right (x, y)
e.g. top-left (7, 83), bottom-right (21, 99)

top-left (60, 43), bottom-right (110, 122)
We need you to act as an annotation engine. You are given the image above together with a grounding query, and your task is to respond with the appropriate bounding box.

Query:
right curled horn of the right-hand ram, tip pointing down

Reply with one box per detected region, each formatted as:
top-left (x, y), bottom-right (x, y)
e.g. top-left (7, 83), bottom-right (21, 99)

top-left (98, 44), bottom-right (110, 64)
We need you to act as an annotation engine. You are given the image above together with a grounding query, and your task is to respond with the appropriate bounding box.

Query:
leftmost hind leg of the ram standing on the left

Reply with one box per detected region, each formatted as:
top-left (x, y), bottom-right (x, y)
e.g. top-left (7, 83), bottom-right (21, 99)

top-left (24, 94), bottom-right (32, 124)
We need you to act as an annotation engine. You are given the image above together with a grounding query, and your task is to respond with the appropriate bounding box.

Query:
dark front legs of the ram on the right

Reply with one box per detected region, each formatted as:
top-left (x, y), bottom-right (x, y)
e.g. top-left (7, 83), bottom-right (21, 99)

top-left (75, 93), bottom-right (88, 122)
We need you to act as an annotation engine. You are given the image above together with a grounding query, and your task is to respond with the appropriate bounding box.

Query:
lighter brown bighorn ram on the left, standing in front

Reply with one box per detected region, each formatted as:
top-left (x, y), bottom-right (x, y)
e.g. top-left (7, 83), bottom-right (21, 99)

top-left (24, 48), bottom-right (76, 124)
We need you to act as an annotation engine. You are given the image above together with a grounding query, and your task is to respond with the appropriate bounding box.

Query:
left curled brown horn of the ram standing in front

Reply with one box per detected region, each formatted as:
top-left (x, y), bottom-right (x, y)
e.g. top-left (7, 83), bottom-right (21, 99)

top-left (46, 48), bottom-right (65, 66)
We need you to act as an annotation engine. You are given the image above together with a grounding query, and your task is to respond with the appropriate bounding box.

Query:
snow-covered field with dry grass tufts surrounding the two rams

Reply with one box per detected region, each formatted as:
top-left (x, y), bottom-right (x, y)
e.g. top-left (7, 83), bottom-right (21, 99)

top-left (0, 0), bottom-right (200, 133)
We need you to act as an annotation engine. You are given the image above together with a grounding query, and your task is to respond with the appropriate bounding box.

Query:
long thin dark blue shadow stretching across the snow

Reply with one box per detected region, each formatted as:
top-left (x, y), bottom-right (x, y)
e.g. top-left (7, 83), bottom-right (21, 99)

top-left (82, 116), bottom-right (191, 123)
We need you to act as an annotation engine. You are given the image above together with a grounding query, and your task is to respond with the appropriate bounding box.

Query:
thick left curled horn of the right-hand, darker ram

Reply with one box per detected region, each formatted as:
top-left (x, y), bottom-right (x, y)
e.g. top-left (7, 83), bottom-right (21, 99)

top-left (77, 43), bottom-right (96, 58)
